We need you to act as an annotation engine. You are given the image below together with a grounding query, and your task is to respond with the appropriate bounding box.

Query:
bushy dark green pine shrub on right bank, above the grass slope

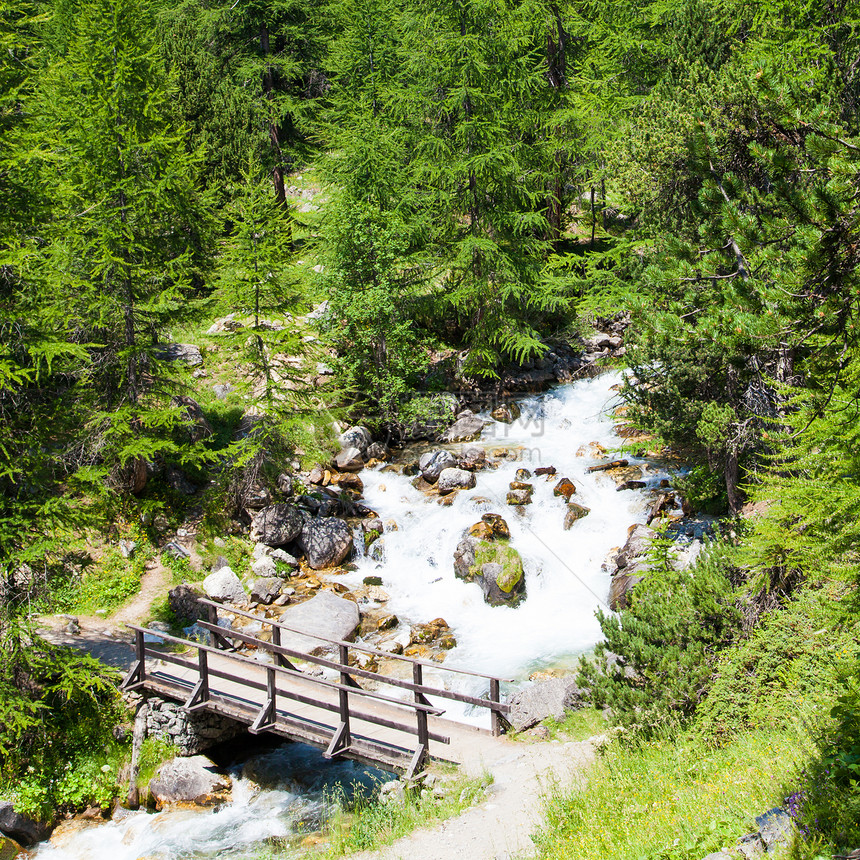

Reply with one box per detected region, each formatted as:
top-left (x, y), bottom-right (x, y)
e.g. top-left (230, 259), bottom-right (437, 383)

top-left (580, 544), bottom-right (742, 733)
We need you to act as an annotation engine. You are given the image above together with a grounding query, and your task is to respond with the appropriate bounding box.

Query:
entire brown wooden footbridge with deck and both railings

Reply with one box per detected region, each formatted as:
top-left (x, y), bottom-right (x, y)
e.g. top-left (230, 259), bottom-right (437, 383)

top-left (123, 600), bottom-right (510, 778)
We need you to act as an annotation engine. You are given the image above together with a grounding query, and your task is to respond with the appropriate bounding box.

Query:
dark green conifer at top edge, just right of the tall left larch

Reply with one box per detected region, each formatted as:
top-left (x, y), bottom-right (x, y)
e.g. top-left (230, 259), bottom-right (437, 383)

top-left (158, 0), bottom-right (333, 203)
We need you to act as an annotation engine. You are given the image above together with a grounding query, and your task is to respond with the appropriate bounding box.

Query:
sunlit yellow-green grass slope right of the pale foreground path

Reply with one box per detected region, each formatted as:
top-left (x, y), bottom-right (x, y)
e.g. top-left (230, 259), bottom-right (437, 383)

top-left (535, 730), bottom-right (813, 860)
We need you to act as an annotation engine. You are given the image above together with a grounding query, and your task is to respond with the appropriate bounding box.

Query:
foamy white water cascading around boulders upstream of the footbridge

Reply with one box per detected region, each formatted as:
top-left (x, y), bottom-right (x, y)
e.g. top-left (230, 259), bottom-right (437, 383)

top-left (340, 373), bottom-right (665, 723)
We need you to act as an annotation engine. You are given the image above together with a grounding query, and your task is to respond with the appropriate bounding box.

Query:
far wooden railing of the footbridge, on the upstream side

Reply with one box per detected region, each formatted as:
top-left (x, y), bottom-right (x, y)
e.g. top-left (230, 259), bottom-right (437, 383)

top-left (198, 598), bottom-right (510, 736)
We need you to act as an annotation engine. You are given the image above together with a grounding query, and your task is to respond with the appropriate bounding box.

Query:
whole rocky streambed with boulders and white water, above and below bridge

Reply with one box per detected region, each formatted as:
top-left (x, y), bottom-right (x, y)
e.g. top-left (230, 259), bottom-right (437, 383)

top-left (28, 373), bottom-right (712, 858)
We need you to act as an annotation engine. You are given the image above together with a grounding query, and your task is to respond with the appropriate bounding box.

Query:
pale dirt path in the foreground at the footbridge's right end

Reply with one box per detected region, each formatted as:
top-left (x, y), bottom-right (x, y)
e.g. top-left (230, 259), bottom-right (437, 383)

top-left (352, 736), bottom-right (604, 860)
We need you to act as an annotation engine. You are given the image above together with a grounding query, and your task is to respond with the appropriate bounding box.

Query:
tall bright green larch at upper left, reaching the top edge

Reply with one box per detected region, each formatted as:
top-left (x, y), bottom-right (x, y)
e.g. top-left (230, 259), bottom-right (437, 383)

top-left (40, 0), bottom-right (215, 490)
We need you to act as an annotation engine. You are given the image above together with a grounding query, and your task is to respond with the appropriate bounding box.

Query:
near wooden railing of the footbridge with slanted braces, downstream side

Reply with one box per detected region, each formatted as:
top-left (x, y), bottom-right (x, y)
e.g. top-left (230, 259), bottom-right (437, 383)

top-left (127, 622), bottom-right (450, 776)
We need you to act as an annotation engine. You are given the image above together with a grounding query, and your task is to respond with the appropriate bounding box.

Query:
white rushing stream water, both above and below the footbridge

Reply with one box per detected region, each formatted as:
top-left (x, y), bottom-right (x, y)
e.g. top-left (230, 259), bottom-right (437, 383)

top-left (37, 374), bottom-right (665, 860)
